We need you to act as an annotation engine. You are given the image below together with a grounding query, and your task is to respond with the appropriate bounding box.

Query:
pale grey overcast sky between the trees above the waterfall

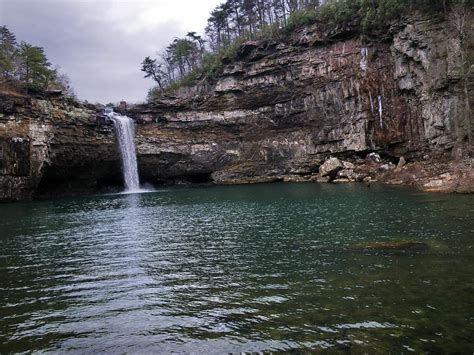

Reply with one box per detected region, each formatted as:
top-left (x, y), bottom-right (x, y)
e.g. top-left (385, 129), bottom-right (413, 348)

top-left (0, 0), bottom-right (222, 103)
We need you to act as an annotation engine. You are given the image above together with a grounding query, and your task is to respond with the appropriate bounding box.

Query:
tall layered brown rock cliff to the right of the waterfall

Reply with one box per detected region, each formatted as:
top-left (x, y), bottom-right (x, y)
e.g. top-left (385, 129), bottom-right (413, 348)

top-left (130, 10), bottom-right (473, 182)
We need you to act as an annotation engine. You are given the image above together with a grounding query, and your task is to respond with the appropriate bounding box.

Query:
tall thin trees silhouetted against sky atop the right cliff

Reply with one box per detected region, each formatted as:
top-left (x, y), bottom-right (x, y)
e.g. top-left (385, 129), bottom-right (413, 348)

top-left (141, 0), bottom-right (327, 96)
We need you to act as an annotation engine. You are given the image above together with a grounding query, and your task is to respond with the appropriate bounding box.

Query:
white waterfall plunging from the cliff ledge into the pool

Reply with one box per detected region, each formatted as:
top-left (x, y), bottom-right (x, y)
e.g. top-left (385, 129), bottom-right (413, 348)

top-left (105, 109), bottom-right (140, 191)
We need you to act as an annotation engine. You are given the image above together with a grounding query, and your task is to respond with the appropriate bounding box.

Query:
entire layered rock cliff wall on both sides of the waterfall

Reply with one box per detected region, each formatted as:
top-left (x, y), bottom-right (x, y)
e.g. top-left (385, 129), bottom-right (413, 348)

top-left (0, 12), bottom-right (474, 200)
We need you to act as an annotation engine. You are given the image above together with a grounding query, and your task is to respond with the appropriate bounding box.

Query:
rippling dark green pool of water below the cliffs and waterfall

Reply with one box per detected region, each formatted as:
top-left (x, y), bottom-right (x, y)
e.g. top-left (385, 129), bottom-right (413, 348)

top-left (0, 184), bottom-right (474, 353)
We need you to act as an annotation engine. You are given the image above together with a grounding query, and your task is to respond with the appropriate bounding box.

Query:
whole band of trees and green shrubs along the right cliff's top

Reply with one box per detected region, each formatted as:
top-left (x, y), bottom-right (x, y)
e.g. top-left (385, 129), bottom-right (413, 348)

top-left (142, 0), bottom-right (474, 100)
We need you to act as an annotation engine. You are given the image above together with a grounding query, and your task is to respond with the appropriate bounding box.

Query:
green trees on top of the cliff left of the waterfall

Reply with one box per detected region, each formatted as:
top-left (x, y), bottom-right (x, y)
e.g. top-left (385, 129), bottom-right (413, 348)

top-left (0, 26), bottom-right (74, 97)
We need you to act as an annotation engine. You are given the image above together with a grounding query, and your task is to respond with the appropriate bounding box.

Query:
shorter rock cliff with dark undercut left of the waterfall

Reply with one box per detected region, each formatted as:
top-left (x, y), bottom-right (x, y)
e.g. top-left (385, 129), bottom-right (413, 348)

top-left (0, 93), bottom-right (120, 201)
